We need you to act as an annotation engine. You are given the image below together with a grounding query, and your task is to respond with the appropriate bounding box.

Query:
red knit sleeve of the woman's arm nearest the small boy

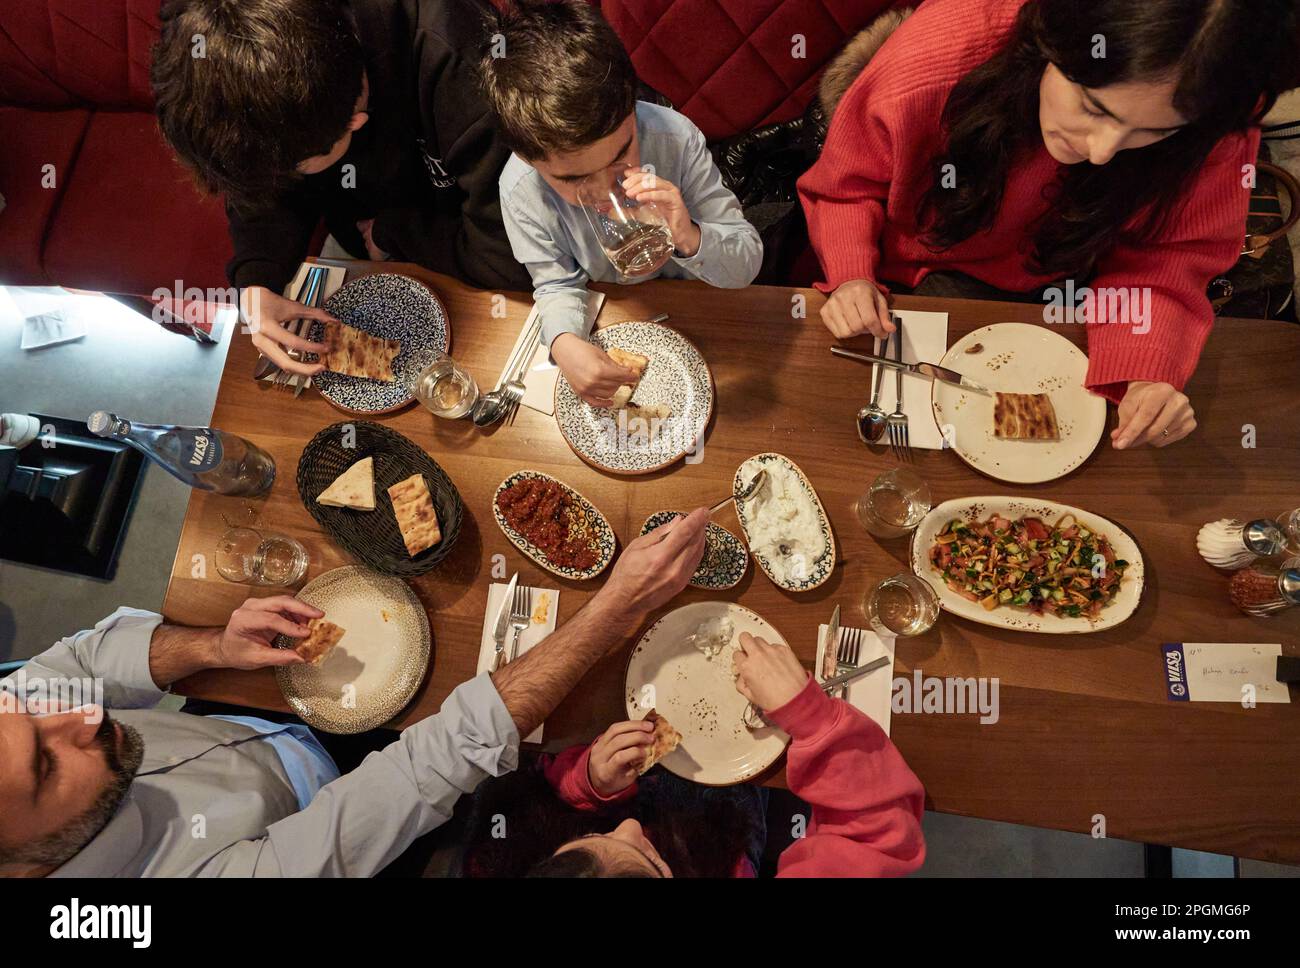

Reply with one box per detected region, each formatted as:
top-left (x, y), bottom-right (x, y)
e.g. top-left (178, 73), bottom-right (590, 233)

top-left (797, 71), bottom-right (893, 292)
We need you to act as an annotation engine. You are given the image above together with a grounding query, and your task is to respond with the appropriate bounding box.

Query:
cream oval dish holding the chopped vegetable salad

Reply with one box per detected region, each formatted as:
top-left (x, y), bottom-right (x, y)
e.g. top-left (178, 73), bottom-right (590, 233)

top-left (911, 496), bottom-right (1147, 634)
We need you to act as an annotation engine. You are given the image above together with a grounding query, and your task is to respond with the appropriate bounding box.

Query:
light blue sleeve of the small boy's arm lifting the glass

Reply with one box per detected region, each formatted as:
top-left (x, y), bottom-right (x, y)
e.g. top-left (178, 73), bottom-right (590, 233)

top-left (672, 125), bottom-right (763, 288)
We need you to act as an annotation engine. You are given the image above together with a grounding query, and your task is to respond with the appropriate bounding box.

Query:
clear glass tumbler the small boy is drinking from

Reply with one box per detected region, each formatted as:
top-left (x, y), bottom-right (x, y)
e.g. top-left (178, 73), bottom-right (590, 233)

top-left (577, 169), bottom-right (673, 279)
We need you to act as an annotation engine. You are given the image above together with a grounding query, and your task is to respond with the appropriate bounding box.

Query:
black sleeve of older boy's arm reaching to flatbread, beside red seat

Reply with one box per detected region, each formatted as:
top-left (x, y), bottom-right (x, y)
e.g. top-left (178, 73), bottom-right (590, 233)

top-left (226, 188), bottom-right (321, 295)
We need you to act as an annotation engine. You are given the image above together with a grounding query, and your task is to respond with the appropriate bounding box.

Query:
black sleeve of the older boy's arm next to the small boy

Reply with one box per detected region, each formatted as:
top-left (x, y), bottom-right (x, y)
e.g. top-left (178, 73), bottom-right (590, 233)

top-left (373, 20), bottom-right (532, 290)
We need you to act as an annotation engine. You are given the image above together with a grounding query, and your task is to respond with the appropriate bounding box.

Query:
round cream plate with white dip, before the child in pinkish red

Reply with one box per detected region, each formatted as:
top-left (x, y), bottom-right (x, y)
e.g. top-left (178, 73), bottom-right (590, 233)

top-left (623, 602), bottom-right (790, 786)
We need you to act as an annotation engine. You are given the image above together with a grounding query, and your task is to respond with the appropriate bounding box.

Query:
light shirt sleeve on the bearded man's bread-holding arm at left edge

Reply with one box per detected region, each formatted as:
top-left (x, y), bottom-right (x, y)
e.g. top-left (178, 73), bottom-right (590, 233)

top-left (0, 605), bottom-right (165, 709)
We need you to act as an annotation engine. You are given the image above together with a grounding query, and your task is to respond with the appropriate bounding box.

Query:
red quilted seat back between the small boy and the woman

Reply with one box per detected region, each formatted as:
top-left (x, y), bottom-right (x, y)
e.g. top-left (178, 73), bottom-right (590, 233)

top-left (601, 0), bottom-right (896, 140)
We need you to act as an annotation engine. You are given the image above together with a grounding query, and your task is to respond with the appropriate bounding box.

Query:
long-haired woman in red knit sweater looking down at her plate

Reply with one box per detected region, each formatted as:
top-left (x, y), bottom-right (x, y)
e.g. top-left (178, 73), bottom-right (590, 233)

top-left (798, 0), bottom-right (1300, 448)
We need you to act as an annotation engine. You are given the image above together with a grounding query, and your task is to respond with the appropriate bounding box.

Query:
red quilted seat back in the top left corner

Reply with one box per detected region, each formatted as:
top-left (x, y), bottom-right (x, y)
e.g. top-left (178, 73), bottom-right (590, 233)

top-left (0, 0), bottom-right (160, 110)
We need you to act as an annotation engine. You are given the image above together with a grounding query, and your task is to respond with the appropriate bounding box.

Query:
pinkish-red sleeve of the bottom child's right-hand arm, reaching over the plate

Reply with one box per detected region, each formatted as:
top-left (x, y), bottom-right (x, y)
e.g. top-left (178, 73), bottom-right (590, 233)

top-left (768, 678), bottom-right (926, 877)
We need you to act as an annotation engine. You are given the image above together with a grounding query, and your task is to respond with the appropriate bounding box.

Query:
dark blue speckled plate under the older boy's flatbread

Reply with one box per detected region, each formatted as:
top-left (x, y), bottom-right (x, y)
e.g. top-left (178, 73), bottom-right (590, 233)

top-left (307, 273), bottom-right (451, 413)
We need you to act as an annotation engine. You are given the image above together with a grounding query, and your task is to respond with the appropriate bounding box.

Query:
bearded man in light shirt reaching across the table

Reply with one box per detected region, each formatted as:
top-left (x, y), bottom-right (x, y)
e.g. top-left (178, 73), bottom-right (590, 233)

top-left (0, 509), bottom-right (707, 877)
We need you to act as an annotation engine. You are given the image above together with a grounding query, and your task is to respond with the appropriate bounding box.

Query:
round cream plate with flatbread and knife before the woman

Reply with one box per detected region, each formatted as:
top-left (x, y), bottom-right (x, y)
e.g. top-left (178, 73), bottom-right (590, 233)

top-left (931, 322), bottom-right (1106, 483)
